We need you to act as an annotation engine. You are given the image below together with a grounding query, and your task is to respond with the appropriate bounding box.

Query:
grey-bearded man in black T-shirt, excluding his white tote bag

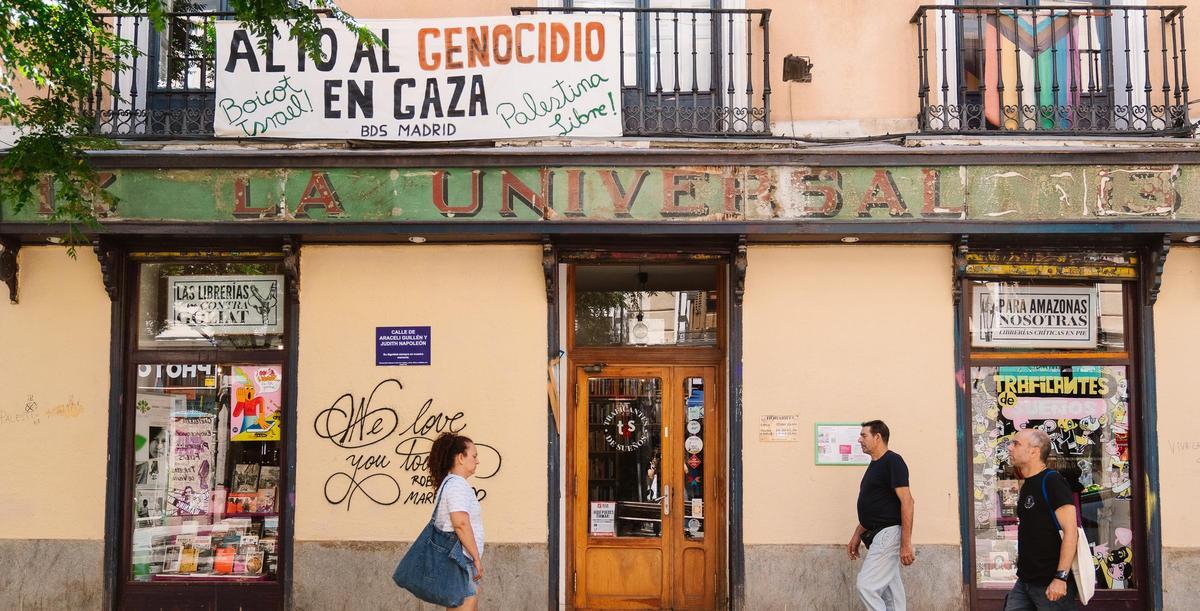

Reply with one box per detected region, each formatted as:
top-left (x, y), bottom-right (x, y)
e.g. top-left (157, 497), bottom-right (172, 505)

top-left (1004, 429), bottom-right (1079, 611)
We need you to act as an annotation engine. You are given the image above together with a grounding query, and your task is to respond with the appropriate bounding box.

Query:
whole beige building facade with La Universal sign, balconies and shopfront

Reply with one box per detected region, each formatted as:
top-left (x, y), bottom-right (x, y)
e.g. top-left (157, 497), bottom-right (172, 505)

top-left (0, 0), bottom-right (1200, 609)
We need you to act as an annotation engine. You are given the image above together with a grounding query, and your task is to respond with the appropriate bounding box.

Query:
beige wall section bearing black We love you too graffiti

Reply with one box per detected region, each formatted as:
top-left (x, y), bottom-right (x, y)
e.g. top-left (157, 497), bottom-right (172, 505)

top-left (296, 245), bottom-right (547, 543)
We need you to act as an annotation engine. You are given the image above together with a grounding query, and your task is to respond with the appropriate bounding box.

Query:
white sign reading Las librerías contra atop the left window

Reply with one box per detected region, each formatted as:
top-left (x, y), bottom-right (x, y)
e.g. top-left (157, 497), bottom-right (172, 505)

top-left (168, 275), bottom-right (283, 339)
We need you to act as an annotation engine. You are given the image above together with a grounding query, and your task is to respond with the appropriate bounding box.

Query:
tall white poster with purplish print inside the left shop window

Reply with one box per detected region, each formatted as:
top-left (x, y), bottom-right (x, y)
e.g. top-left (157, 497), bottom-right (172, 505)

top-left (166, 415), bottom-right (217, 516)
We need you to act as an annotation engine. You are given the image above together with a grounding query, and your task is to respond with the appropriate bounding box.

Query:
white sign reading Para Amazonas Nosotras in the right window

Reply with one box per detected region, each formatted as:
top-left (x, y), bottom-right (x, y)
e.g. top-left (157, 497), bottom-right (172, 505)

top-left (971, 282), bottom-right (1099, 348)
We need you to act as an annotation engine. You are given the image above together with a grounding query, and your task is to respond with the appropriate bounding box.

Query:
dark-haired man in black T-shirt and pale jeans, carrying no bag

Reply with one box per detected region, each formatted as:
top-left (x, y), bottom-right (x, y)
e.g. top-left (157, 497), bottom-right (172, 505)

top-left (846, 420), bottom-right (916, 611)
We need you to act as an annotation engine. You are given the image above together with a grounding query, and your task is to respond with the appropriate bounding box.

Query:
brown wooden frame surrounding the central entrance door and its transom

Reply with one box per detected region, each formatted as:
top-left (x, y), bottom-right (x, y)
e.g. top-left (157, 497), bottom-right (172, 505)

top-left (560, 256), bottom-right (740, 609)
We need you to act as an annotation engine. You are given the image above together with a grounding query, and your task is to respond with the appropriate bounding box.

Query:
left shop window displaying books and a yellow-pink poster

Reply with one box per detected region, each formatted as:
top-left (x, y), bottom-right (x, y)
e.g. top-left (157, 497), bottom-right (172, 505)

top-left (127, 258), bottom-right (288, 583)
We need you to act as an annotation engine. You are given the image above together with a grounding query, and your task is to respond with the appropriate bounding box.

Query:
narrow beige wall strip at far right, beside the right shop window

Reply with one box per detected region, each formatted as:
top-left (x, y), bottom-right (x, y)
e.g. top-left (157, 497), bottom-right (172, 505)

top-left (1154, 247), bottom-right (1200, 547)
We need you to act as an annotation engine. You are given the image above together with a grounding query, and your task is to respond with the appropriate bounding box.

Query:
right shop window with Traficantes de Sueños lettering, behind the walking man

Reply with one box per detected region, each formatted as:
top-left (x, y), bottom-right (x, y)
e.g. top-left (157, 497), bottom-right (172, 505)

top-left (965, 248), bottom-right (1141, 599)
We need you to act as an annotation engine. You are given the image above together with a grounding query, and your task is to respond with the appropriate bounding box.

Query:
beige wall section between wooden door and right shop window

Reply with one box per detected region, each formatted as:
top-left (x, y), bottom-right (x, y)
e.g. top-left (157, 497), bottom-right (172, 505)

top-left (743, 245), bottom-right (959, 545)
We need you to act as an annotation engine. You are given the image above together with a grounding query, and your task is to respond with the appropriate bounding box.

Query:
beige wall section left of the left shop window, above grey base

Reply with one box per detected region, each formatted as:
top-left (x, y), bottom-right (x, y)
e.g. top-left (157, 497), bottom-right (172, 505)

top-left (0, 247), bottom-right (110, 539)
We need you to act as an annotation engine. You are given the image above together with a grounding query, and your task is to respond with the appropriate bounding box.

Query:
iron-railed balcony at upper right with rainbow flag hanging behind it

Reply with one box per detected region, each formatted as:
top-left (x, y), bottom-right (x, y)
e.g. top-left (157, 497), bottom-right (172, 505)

top-left (912, 0), bottom-right (1192, 136)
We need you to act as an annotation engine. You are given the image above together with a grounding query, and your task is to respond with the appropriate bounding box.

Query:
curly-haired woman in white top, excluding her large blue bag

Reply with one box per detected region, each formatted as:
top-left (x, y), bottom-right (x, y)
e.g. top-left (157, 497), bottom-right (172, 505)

top-left (430, 433), bottom-right (484, 611)
